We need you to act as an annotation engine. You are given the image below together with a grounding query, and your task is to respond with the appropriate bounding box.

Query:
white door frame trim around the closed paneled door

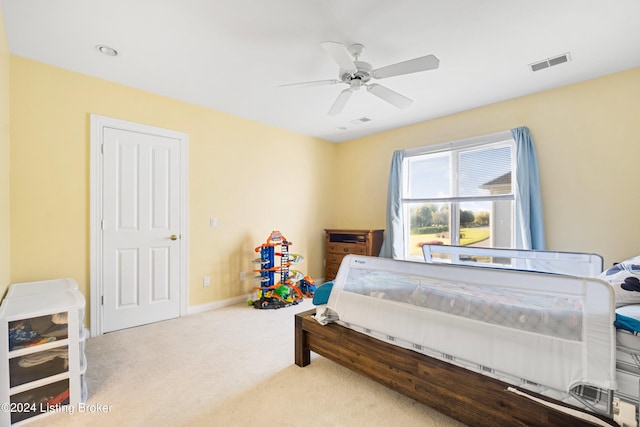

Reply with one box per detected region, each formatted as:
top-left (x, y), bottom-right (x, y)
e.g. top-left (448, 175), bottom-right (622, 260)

top-left (89, 114), bottom-right (189, 336)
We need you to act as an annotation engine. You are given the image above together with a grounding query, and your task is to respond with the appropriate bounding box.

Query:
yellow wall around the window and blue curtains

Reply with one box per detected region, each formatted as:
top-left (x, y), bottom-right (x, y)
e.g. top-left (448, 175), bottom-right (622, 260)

top-left (333, 68), bottom-right (640, 265)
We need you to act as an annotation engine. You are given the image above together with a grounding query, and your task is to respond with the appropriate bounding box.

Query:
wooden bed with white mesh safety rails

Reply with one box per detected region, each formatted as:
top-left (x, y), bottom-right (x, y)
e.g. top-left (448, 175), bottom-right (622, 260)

top-left (295, 247), bottom-right (638, 426)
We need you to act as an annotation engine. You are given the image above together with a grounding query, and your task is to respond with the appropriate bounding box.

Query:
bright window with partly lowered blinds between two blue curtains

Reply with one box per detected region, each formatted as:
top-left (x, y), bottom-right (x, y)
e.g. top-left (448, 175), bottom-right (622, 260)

top-left (402, 132), bottom-right (515, 259)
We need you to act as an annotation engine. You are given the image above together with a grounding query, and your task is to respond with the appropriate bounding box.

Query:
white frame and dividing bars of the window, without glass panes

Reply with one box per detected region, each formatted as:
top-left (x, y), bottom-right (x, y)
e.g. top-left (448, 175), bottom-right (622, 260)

top-left (400, 131), bottom-right (518, 261)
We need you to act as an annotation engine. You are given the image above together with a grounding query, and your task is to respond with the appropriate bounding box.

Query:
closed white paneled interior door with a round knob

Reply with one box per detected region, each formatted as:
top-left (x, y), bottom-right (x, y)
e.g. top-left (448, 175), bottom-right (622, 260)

top-left (92, 115), bottom-right (186, 333)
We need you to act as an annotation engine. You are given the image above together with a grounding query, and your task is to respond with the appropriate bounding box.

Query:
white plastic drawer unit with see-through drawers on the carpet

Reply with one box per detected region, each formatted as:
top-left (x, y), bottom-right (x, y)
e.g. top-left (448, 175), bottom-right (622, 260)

top-left (0, 279), bottom-right (86, 426)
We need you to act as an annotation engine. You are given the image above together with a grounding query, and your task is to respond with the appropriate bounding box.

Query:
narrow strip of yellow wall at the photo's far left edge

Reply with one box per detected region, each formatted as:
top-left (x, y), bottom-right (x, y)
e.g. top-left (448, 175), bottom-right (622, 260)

top-left (0, 9), bottom-right (11, 298)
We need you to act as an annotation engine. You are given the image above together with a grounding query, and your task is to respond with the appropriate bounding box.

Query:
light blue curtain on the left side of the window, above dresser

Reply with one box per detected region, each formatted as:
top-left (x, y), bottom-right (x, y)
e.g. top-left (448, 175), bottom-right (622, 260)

top-left (380, 150), bottom-right (405, 259)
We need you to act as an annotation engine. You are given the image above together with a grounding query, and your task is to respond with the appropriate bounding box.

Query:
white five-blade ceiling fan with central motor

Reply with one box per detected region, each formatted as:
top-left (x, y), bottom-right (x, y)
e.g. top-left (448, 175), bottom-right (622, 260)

top-left (280, 41), bottom-right (440, 116)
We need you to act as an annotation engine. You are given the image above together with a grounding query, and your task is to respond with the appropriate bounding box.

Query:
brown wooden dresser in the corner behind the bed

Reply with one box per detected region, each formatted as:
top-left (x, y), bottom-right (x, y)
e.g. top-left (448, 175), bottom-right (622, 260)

top-left (324, 229), bottom-right (384, 282)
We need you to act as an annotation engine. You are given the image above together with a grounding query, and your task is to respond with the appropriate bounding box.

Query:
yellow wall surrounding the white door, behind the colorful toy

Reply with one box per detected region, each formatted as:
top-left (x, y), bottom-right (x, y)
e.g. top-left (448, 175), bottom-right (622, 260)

top-left (11, 56), bottom-right (337, 319)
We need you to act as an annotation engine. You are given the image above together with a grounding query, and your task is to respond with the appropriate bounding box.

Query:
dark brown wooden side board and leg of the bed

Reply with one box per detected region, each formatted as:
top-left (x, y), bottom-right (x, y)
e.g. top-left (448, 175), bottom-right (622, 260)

top-left (295, 310), bottom-right (617, 427)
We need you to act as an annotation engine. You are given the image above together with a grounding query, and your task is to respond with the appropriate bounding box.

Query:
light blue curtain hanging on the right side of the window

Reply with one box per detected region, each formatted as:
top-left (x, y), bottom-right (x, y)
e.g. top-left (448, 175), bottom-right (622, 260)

top-left (511, 126), bottom-right (545, 250)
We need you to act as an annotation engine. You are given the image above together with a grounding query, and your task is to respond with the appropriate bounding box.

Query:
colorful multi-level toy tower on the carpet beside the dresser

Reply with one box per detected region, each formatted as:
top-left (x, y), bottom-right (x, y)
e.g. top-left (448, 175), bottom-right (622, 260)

top-left (249, 231), bottom-right (315, 309)
